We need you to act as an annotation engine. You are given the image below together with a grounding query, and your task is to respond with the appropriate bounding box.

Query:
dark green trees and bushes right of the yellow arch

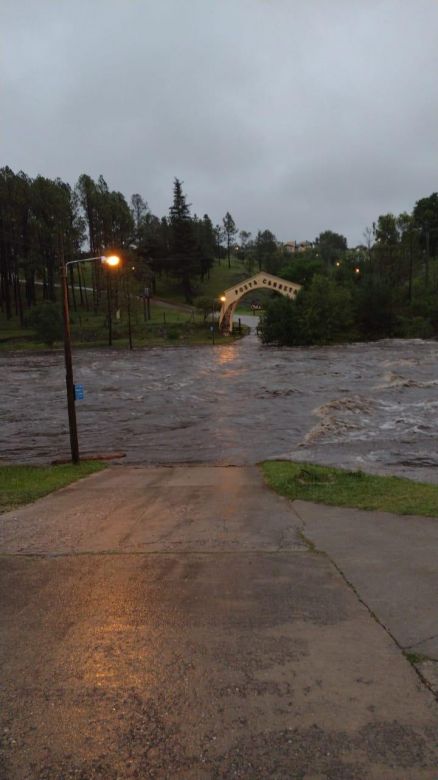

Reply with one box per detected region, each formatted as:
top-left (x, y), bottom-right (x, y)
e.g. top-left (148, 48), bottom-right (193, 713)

top-left (261, 193), bottom-right (438, 346)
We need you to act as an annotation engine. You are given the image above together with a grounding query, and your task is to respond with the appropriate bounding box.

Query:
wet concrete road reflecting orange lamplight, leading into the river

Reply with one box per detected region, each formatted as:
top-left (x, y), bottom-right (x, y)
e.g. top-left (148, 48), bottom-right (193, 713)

top-left (0, 466), bottom-right (438, 780)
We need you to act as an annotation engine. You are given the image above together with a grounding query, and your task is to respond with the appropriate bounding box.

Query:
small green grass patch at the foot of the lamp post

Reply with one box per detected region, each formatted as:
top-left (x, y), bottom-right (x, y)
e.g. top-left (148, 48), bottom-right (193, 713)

top-left (0, 461), bottom-right (106, 513)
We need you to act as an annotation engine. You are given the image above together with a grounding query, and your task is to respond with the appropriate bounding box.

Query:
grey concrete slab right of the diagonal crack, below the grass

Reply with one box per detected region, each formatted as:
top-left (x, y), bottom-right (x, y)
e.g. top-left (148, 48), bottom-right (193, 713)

top-left (293, 501), bottom-right (438, 660)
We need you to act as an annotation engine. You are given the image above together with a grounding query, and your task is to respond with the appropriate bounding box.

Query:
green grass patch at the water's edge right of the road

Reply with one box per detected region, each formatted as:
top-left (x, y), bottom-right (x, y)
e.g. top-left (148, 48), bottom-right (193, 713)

top-left (261, 461), bottom-right (438, 517)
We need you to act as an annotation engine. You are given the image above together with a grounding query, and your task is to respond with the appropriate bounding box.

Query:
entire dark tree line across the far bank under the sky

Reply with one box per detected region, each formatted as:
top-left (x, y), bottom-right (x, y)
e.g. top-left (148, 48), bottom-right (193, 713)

top-left (0, 167), bottom-right (438, 344)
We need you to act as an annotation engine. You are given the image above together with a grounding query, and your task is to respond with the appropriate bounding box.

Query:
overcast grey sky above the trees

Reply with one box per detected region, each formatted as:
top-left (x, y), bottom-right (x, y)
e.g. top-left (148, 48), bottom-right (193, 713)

top-left (0, 0), bottom-right (438, 244)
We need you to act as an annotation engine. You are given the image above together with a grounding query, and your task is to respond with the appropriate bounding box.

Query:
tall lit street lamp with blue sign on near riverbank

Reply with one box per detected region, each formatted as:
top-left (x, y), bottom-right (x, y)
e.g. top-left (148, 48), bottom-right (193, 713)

top-left (60, 255), bottom-right (120, 464)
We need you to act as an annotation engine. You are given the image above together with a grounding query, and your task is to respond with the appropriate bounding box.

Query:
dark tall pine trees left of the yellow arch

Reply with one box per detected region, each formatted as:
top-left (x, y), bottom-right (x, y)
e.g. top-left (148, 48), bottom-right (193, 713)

top-left (0, 167), bottom-right (243, 325)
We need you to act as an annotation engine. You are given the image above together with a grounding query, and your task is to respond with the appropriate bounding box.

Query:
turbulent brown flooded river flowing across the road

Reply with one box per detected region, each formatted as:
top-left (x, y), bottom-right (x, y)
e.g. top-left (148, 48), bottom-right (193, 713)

top-left (0, 322), bottom-right (438, 482)
